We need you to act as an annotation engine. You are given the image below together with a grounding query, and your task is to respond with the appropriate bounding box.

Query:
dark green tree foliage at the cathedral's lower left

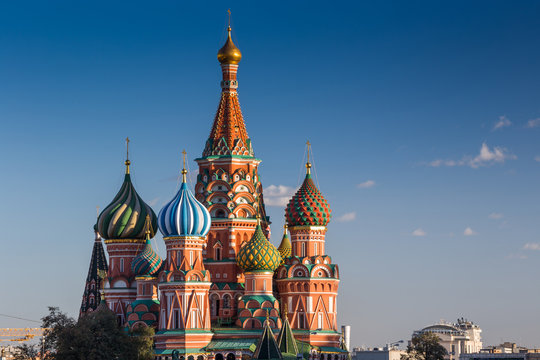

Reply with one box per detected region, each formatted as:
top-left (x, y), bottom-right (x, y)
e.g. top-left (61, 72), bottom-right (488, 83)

top-left (42, 308), bottom-right (154, 360)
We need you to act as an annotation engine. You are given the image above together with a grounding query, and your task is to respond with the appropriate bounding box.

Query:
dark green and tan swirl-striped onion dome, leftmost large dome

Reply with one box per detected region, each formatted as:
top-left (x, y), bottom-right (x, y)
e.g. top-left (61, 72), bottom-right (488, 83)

top-left (96, 174), bottom-right (157, 240)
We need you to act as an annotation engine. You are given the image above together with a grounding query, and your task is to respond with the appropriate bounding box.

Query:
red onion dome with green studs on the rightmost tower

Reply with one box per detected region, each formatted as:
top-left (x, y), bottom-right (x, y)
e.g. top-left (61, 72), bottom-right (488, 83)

top-left (285, 173), bottom-right (332, 226)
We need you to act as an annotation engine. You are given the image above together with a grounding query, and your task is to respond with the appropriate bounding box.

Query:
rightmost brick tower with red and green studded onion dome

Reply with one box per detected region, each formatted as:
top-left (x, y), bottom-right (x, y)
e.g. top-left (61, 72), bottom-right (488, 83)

top-left (277, 150), bottom-right (340, 348)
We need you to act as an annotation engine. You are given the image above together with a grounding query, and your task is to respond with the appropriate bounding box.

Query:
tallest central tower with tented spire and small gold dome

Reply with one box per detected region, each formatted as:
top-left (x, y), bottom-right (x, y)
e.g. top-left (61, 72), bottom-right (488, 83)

top-left (195, 26), bottom-right (269, 324)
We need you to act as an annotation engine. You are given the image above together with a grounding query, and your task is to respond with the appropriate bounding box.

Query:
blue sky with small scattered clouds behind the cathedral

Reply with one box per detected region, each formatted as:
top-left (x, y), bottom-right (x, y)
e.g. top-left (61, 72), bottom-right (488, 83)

top-left (0, 1), bottom-right (540, 346)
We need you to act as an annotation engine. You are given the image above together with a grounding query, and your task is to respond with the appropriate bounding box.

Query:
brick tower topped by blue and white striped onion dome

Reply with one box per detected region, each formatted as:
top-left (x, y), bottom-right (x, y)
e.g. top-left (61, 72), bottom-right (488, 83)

top-left (155, 152), bottom-right (213, 356)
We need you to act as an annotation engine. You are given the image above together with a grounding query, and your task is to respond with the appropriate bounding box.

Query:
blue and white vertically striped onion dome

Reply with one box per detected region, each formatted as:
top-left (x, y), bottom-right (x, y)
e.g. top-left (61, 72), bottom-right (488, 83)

top-left (158, 182), bottom-right (211, 237)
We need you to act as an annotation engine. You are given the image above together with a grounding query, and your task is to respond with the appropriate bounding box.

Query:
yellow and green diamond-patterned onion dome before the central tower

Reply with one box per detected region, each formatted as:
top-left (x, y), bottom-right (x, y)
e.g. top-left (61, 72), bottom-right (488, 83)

top-left (236, 219), bottom-right (282, 271)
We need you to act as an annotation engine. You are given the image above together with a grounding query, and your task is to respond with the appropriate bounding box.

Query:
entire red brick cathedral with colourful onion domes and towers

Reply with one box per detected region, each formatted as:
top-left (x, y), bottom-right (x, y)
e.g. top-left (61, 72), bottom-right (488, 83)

top-left (81, 26), bottom-right (348, 360)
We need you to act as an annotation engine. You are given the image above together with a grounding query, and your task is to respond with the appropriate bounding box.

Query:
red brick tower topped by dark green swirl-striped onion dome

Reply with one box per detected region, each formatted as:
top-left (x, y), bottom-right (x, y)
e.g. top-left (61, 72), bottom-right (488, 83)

top-left (97, 139), bottom-right (157, 325)
